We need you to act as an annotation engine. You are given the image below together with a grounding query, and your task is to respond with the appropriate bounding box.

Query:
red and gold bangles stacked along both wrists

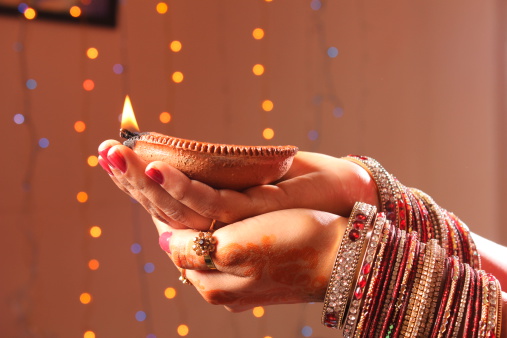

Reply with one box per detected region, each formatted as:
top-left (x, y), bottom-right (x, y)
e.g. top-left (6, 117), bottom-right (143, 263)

top-left (322, 156), bottom-right (502, 337)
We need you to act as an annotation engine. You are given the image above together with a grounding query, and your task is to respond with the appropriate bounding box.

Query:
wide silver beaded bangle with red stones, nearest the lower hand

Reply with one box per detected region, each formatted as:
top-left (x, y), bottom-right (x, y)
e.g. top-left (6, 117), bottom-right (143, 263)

top-left (322, 202), bottom-right (377, 328)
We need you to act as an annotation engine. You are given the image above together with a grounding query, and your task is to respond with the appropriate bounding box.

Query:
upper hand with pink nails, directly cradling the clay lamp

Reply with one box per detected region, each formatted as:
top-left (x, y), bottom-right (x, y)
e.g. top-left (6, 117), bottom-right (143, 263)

top-left (99, 140), bottom-right (378, 230)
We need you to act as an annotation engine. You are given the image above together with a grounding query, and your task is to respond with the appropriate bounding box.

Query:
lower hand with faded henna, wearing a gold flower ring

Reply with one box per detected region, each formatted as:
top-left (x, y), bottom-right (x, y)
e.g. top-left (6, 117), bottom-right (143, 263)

top-left (155, 209), bottom-right (347, 312)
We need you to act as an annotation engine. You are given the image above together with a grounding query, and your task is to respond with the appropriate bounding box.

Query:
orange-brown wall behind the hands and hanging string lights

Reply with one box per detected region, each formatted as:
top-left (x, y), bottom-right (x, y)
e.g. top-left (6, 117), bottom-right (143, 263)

top-left (0, 0), bottom-right (507, 338)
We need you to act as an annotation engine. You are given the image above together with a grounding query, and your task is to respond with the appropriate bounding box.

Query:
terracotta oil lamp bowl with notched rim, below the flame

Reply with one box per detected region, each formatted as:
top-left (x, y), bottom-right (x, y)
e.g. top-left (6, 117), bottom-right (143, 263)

top-left (120, 129), bottom-right (298, 190)
